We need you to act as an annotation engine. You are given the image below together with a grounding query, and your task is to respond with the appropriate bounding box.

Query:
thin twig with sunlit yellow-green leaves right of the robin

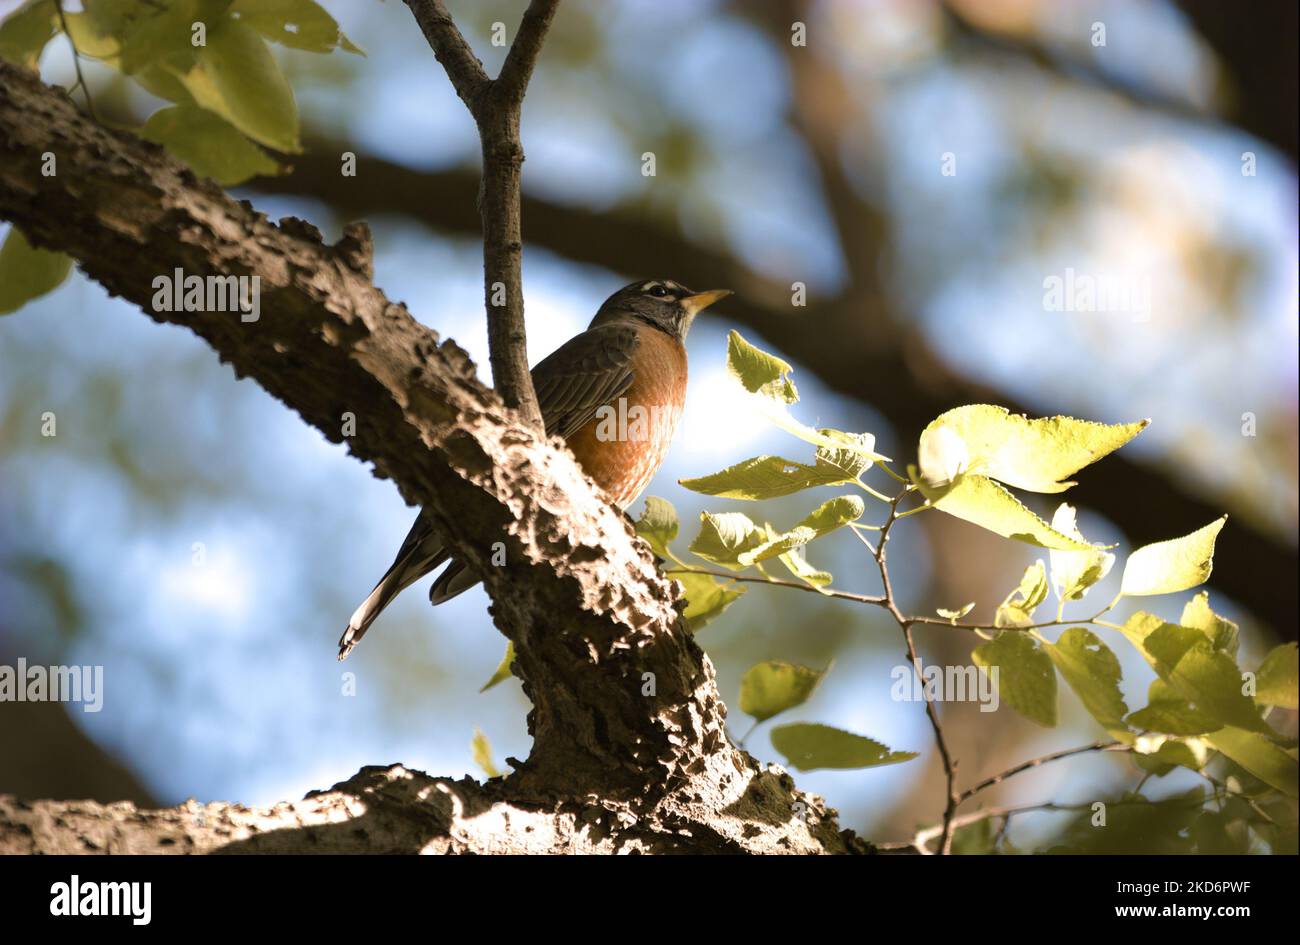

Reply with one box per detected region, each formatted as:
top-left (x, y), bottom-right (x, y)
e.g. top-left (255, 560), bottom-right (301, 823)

top-left (637, 331), bottom-right (1296, 854)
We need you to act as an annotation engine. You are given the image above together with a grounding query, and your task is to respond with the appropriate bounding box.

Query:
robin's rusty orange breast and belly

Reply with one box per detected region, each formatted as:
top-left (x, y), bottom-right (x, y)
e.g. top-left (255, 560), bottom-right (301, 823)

top-left (568, 325), bottom-right (686, 508)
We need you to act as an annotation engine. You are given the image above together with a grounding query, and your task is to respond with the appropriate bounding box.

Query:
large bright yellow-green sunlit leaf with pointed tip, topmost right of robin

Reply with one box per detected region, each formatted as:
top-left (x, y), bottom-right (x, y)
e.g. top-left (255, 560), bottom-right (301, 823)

top-left (922, 404), bottom-right (1148, 493)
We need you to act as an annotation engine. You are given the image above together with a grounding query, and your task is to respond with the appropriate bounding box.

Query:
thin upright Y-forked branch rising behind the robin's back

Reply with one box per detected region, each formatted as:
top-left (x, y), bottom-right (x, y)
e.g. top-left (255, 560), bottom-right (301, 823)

top-left (397, 0), bottom-right (559, 430)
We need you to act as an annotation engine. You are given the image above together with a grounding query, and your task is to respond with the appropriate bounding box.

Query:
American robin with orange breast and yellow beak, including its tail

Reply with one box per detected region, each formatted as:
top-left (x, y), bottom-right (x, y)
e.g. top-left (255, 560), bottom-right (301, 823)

top-left (338, 279), bottom-right (731, 659)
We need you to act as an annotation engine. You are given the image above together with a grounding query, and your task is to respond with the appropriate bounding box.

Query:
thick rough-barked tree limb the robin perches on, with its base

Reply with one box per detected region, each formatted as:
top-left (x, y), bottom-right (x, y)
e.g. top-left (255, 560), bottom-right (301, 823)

top-left (0, 62), bottom-right (867, 853)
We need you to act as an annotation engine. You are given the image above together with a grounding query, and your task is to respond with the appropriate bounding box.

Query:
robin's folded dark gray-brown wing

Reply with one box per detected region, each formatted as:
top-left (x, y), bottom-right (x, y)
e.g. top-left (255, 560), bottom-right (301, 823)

top-left (533, 325), bottom-right (640, 439)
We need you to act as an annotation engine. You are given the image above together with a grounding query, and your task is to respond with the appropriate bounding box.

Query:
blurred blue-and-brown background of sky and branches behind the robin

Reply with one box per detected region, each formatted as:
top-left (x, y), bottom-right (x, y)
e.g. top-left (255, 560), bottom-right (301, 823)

top-left (0, 0), bottom-right (1297, 849)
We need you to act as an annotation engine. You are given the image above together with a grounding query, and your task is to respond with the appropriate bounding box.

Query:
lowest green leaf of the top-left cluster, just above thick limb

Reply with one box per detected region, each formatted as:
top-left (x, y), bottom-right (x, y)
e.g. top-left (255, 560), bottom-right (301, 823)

top-left (140, 105), bottom-right (281, 187)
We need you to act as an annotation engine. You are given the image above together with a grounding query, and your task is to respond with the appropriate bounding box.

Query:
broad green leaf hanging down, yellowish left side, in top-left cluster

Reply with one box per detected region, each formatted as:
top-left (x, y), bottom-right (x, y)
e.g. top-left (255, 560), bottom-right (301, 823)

top-left (170, 19), bottom-right (302, 153)
